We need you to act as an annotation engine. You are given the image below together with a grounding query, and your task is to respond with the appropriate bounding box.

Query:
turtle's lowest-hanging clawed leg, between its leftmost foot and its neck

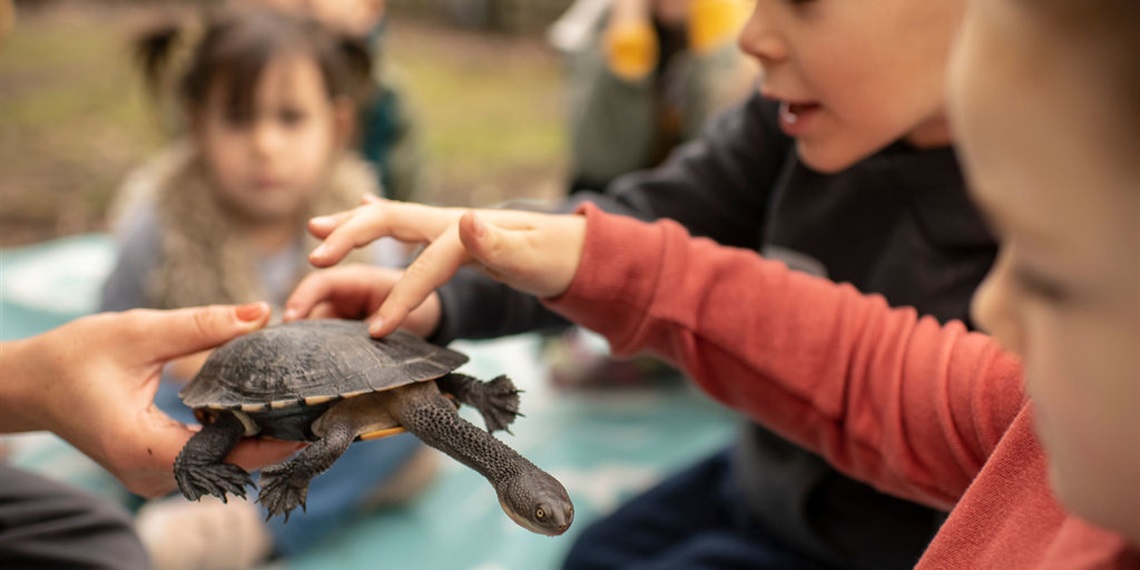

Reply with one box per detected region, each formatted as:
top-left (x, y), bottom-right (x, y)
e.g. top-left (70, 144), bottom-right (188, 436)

top-left (258, 423), bottom-right (356, 522)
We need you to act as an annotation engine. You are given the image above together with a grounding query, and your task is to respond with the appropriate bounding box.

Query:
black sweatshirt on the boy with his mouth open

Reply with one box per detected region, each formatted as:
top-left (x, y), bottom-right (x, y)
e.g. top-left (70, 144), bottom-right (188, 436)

top-left (432, 96), bottom-right (996, 569)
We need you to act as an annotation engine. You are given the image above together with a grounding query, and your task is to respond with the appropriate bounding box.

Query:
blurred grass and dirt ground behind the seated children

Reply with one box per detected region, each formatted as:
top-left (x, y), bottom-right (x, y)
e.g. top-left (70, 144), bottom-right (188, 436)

top-left (0, 2), bottom-right (564, 247)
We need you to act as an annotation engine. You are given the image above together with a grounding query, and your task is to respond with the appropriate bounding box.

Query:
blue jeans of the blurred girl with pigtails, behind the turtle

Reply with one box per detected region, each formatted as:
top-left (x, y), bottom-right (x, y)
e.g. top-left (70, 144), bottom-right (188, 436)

top-left (154, 382), bottom-right (423, 556)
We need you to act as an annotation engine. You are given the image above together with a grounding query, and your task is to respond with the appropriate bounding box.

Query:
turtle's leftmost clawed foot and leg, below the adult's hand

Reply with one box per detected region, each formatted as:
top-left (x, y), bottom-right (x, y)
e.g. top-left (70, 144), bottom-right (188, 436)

top-left (174, 412), bottom-right (253, 503)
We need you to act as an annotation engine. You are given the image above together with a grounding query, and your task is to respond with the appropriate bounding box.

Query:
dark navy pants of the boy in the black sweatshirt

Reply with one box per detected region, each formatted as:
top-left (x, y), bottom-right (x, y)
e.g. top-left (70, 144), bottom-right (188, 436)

top-left (563, 450), bottom-right (829, 570)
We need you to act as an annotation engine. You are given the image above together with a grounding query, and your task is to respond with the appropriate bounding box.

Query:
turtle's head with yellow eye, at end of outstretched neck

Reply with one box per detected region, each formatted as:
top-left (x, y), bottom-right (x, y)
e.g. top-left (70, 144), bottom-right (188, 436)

top-left (499, 467), bottom-right (573, 536)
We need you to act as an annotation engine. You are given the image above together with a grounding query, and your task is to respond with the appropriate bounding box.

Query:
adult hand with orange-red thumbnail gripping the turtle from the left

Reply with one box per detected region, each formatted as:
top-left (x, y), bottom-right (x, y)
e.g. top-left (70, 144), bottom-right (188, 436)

top-left (0, 303), bottom-right (301, 497)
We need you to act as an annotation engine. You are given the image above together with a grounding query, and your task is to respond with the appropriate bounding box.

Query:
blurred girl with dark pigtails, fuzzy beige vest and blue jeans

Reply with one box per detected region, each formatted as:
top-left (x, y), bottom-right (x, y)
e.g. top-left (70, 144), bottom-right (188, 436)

top-left (101, 7), bottom-right (431, 569)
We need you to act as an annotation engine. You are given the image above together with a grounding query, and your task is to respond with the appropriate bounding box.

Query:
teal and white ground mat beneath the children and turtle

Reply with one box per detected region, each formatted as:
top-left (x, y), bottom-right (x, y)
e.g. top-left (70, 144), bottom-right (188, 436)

top-left (0, 235), bottom-right (735, 570)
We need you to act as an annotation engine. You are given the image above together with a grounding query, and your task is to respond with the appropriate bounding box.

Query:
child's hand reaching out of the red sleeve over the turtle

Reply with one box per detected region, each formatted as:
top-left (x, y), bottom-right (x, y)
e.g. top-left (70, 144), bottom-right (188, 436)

top-left (309, 201), bottom-right (586, 336)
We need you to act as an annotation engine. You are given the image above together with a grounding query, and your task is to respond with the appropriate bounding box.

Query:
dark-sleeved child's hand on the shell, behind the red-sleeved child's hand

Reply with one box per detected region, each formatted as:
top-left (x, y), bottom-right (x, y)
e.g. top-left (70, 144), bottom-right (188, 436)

top-left (284, 264), bottom-right (441, 337)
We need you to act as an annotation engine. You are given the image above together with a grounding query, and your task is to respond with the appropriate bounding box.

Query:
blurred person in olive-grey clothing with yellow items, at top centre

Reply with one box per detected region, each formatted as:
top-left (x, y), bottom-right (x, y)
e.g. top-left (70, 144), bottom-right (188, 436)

top-left (549, 0), bottom-right (757, 193)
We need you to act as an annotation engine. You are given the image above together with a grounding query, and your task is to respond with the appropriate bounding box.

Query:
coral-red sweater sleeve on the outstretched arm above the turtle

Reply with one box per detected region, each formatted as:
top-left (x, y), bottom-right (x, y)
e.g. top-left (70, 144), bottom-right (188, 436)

top-left (546, 205), bottom-right (1025, 508)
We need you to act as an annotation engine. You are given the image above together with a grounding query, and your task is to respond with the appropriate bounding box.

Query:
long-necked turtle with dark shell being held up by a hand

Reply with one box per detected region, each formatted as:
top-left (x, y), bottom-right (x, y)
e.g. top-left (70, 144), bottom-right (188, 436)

top-left (174, 319), bottom-right (573, 536)
